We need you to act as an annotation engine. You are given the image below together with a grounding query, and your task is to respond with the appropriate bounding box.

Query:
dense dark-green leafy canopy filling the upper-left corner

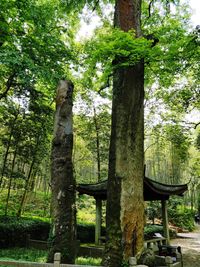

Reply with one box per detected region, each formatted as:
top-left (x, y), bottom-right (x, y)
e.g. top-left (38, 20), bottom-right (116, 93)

top-left (0, 0), bottom-right (74, 99)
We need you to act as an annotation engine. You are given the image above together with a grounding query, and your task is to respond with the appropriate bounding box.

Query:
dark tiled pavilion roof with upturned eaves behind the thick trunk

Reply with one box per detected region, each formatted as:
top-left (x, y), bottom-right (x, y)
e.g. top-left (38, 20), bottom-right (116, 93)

top-left (77, 177), bottom-right (188, 201)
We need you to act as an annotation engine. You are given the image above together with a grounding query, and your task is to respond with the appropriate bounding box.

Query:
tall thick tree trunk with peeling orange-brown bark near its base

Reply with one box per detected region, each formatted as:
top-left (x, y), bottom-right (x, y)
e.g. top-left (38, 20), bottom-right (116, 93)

top-left (105, 0), bottom-right (144, 267)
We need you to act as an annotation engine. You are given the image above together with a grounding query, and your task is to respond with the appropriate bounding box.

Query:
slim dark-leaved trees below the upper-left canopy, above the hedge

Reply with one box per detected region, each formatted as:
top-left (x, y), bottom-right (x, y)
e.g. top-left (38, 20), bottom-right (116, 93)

top-left (0, 89), bottom-right (52, 216)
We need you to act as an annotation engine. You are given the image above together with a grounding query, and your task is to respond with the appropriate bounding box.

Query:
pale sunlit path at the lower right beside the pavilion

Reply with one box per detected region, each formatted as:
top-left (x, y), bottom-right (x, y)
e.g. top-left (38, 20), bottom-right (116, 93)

top-left (171, 225), bottom-right (200, 267)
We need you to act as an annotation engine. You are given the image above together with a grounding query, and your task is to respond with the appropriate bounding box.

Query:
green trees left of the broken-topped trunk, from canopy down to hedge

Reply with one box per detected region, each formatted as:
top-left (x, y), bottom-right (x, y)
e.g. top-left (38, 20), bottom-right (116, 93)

top-left (0, 1), bottom-right (73, 219)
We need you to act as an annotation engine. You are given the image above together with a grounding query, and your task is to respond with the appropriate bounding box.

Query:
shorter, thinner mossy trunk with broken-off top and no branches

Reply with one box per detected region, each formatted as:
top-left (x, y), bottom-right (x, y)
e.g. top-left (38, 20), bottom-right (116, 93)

top-left (48, 80), bottom-right (76, 263)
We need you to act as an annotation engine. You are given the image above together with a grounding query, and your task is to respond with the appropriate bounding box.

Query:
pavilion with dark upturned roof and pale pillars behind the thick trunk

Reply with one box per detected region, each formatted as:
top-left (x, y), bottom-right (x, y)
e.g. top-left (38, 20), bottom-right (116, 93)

top-left (77, 177), bottom-right (188, 244)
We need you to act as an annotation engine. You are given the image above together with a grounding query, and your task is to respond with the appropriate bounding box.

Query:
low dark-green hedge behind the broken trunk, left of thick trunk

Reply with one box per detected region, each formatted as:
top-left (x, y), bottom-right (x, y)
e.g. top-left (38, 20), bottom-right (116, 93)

top-left (0, 216), bottom-right (105, 248)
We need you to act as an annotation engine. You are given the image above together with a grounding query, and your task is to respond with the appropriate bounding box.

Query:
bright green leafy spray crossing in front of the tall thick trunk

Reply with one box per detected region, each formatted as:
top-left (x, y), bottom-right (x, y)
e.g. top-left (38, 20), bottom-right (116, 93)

top-left (82, 25), bottom-right (152, 89)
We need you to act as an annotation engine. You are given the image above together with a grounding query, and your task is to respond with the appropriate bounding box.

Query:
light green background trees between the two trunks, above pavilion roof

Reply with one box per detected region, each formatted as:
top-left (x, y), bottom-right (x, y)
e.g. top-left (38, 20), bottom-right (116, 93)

top-left (74, 103), bottom-right (110, 183)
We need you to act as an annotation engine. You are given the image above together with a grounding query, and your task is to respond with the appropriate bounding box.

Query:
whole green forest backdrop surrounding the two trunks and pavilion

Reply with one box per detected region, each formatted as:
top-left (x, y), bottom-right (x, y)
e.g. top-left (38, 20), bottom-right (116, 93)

top-left (0, 0), bottom-right (200, 266)
